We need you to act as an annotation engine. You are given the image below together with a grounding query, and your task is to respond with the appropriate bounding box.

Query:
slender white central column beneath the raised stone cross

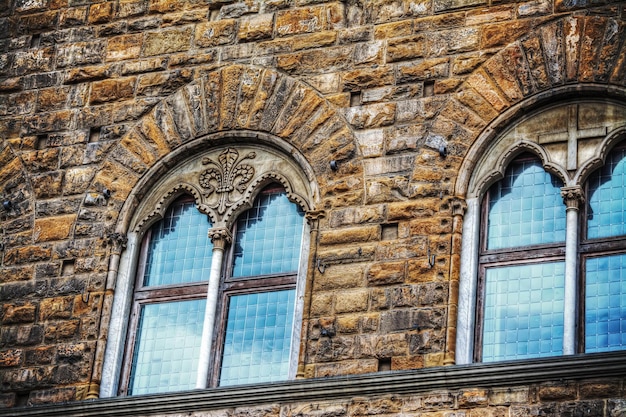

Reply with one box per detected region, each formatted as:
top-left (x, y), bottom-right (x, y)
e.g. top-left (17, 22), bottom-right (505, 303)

top-left (561, 186), bottom-right (584, 355)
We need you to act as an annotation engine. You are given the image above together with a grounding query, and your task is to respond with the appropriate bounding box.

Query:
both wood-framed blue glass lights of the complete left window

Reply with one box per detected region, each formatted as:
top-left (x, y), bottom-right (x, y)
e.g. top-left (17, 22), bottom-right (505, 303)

top-left (120, 186), bottom-right (304, 395)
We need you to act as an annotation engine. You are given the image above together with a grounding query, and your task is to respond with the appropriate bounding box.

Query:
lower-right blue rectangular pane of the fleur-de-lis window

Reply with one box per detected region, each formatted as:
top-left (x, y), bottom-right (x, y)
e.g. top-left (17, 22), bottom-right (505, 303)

top-left (220, 290), bottom-right (295, 386)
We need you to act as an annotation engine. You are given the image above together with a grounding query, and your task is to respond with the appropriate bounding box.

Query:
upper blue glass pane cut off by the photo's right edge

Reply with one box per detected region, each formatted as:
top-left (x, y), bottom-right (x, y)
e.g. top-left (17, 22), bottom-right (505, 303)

top-left (587, 149), bottom-right (626, 239)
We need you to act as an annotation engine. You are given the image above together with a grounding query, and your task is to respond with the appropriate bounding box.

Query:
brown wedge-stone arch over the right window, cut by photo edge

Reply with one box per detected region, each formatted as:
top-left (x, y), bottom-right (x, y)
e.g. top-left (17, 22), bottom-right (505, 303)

top-left (438, 16), bottom-right (626, 197)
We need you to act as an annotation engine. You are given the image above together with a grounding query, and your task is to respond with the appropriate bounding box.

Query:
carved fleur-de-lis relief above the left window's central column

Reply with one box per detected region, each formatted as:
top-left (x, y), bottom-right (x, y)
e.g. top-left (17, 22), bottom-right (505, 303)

top-left (198, 148), bottom-right (256, 215)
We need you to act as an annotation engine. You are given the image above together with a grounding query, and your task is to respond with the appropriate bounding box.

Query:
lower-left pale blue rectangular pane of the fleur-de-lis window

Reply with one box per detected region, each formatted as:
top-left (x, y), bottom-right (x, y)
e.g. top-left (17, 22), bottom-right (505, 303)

top-left (129, 300), bottom-right (206, 395)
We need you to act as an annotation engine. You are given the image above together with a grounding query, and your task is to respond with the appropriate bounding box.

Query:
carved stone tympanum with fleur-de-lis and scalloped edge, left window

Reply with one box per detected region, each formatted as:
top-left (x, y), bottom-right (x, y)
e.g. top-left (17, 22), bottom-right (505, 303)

top-left (131, 146), bottom-right (314, 232)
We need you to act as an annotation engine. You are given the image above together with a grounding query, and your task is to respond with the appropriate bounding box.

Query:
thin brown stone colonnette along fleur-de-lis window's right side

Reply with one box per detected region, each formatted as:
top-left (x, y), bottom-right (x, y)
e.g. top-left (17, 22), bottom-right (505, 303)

top-left (296, 210), bottom-right (326, 379)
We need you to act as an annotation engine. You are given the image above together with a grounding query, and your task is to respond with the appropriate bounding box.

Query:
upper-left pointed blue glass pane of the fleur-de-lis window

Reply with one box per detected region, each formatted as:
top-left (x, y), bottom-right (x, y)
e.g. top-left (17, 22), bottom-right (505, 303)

top-left (144, 202), bottom-right (213, 286)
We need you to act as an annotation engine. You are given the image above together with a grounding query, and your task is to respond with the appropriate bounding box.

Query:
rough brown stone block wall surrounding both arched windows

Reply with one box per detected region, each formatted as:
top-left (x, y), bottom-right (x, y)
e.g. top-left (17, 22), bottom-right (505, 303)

top-left (0, 0), bottom-right (626, 408)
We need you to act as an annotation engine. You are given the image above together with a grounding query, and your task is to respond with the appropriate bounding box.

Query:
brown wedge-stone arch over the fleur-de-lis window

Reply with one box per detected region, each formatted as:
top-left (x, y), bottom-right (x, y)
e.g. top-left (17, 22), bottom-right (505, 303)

top-left (80, 61), bottom-right (358, 237)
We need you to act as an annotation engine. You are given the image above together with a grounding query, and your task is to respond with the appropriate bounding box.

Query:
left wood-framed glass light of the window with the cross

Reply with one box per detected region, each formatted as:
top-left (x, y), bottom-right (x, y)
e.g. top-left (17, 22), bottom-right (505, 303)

top-left (476, 156), bottom-right (565, 362)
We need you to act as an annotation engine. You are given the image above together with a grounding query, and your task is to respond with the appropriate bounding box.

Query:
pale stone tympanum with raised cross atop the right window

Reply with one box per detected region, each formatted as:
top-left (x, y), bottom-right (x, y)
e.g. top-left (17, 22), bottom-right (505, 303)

top-left (460, 99), bottom-right (626, 198)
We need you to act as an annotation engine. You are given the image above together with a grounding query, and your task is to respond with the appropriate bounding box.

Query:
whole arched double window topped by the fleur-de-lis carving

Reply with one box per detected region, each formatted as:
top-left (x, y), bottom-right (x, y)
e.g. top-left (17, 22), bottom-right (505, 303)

top-left (101, 145), bottom-right (316, 397)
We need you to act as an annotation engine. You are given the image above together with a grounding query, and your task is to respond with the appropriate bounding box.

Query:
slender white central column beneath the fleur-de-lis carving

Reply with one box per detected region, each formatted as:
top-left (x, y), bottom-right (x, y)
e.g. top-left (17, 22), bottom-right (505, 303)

top-left (196, 228), bottom-right (233, 388)
